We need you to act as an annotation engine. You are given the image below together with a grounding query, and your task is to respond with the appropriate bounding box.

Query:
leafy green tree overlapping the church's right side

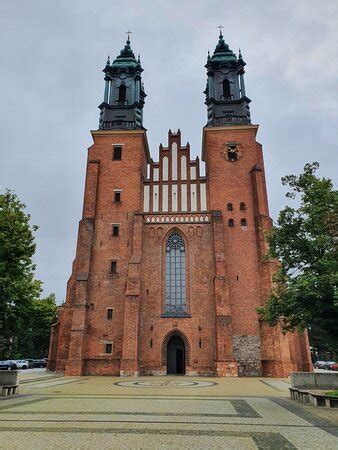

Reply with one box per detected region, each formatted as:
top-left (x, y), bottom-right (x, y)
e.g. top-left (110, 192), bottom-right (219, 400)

top-left (258, 162), bottom-right (338, 352)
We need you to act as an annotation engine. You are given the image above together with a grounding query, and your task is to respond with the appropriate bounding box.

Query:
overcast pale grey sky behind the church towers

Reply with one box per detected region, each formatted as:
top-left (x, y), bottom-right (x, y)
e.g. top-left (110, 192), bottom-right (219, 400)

top-left (0, 0), bottom-right (338, 303)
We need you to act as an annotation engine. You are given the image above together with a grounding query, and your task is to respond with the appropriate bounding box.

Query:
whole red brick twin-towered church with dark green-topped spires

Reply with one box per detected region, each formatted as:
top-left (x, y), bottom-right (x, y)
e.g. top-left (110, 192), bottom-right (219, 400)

top-left (49, 33), bottom-right (311, 377)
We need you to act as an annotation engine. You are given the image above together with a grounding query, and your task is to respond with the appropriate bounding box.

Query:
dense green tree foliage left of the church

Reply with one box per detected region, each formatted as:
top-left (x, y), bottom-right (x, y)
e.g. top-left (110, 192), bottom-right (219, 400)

top-left (0, 191), bottom-right (56, 358)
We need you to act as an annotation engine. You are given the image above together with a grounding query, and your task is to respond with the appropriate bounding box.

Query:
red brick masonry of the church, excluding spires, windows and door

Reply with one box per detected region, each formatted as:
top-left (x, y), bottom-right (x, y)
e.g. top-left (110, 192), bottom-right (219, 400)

top-left (48, 125), bottom-right (312, 377)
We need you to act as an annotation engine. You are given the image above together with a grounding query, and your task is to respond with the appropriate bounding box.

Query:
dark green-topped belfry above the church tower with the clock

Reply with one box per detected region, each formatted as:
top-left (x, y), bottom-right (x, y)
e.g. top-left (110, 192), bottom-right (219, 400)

top-left (204, 27), bottom-right (251, 126)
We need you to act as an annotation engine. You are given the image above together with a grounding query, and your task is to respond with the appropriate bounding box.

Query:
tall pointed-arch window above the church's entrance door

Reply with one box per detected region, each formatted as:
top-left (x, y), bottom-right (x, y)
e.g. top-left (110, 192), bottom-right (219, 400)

top-left (165, 231), bottom-right (187, 315)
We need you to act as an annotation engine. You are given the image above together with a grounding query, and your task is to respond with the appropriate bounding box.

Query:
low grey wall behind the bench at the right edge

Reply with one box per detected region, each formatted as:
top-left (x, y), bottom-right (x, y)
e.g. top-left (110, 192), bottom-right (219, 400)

top-left (290, 372), bottom-right (338, 389)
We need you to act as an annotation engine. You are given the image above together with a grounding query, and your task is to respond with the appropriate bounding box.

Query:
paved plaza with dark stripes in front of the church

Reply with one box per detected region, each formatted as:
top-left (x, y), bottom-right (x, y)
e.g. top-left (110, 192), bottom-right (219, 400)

top-left (0, 374), bottom-right (338, 449)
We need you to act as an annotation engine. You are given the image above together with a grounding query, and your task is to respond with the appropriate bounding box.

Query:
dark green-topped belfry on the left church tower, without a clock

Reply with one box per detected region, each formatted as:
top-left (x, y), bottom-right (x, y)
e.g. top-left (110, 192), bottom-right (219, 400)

top-left (99, 33), bottom-right (146, 130)
